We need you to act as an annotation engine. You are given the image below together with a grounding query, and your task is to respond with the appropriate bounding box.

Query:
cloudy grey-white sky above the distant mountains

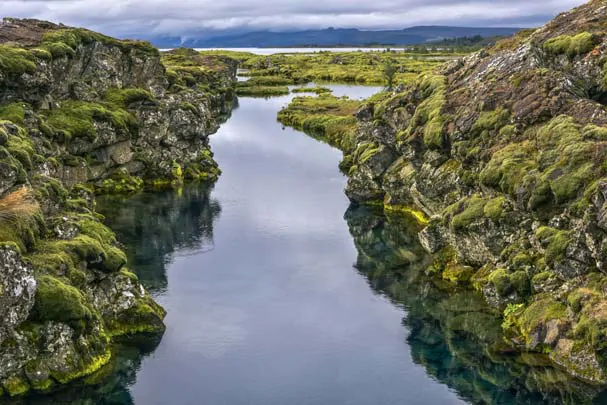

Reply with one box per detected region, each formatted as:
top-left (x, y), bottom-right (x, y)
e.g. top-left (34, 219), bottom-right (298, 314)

top-left (0, 0), bottom-right (584, 36)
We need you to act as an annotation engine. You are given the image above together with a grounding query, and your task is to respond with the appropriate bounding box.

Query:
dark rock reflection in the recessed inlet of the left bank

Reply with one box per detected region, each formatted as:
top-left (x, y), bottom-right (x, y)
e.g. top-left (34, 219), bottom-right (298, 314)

top-left (98, 184), bottom-right (221, 294)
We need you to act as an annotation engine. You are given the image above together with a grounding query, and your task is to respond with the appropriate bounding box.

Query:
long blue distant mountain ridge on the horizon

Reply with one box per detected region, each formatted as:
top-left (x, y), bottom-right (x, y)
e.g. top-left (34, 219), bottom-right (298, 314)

top-left (146, 26), bottom-right (519, 48)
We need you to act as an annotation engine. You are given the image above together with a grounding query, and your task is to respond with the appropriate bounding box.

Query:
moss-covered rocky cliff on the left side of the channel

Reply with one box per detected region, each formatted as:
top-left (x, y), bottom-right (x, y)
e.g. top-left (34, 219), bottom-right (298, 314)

top-left (0, 19), bottom-right (236, 396)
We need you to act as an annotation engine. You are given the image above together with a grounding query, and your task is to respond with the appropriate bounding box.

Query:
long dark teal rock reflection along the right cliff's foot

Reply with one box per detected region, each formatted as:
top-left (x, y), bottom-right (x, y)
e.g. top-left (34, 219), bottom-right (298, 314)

top-left (345, 207), bottom-right (605, 405)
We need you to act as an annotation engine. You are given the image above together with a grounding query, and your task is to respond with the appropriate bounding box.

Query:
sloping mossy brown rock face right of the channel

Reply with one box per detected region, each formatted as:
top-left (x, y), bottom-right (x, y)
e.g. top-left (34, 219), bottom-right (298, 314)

top-left (345, 0), bottom-right (607, 383)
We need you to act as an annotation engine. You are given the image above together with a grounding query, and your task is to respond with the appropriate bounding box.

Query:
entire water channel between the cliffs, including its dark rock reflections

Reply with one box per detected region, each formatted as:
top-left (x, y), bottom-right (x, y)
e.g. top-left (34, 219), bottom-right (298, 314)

top-left (28, 86), bottom-right (601, 405)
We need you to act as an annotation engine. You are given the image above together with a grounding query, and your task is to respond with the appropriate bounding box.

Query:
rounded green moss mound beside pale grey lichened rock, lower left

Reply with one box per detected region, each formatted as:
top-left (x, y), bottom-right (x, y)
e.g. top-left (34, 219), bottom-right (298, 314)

top-left (33, 275), bottom-right (93, 333)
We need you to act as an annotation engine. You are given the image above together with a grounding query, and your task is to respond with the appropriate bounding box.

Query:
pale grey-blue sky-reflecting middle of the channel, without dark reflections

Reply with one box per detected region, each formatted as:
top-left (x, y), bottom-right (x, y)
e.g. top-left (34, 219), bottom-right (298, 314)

top-left (121, 86), bottom-right (460, 405)
